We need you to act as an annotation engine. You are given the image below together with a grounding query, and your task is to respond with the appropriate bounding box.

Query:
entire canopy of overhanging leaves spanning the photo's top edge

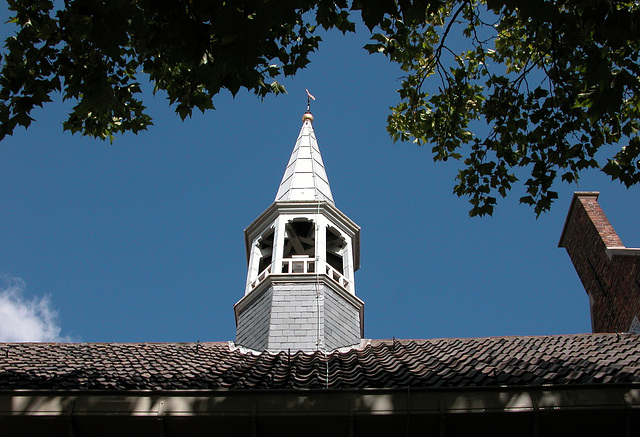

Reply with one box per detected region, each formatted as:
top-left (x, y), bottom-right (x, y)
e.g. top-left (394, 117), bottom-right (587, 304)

top-left (0, 0), bottom-right (640, 215)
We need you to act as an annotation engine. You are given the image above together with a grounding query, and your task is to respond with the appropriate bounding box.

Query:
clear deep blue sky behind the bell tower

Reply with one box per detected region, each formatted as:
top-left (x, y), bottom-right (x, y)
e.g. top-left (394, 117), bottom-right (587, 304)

top-left (0, 11), bottom-right (640, 342)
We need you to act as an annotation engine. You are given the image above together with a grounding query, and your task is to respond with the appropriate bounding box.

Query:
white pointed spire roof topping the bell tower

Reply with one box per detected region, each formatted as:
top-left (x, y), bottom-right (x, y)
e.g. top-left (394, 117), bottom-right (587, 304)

top-left (276, 112), bottom-right (333, 203)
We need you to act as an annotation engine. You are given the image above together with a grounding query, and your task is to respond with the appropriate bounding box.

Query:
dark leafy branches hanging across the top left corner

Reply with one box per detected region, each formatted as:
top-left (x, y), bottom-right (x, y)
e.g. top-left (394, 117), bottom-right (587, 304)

top-left (0, 0), bottom-right (352, 139)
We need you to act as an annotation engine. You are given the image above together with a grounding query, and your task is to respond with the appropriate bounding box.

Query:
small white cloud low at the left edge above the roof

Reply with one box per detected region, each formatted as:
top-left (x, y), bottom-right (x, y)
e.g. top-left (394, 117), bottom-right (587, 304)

top-left (0, 275), bottom-right (70, 342)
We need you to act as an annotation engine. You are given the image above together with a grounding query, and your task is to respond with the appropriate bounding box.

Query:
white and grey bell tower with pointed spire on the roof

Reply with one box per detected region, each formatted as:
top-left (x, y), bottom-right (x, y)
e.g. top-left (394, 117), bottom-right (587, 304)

top-left (234, 109), bottom-right (364, 351)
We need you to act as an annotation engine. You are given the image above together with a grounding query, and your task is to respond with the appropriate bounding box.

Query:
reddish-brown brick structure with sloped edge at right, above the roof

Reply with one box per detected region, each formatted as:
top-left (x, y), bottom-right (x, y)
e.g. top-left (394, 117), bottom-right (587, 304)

top-left (558, 191), bottom-right (640, 333)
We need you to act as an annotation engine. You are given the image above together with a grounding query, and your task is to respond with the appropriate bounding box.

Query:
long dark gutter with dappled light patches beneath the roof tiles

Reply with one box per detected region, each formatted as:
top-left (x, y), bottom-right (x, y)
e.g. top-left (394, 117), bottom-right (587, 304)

top-left (0, 384), bottom-right (640, 418)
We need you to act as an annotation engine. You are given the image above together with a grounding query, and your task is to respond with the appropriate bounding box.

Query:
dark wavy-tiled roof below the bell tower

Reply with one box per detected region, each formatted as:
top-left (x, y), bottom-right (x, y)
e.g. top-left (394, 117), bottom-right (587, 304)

top-left (0, 334), bottom-right (640, 390)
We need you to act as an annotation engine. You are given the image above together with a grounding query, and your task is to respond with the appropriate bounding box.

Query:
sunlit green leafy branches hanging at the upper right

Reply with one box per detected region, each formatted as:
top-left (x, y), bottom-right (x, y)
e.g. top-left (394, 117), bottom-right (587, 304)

top-left (376, 0), bottom-right (640, 216)
